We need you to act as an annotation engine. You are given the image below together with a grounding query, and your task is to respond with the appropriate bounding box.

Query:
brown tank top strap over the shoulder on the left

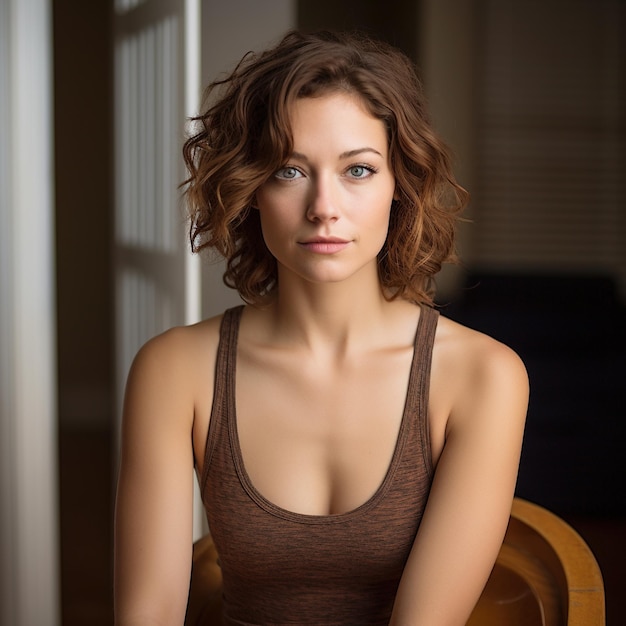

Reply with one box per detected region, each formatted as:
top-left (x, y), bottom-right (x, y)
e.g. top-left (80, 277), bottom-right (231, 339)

top-left (200, 305), bottom-right (244, 493)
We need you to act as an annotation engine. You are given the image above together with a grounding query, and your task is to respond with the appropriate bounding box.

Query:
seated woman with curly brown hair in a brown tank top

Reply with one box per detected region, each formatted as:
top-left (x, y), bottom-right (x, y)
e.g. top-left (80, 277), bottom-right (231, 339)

top-left (115, 32), bottom-right (528, 626)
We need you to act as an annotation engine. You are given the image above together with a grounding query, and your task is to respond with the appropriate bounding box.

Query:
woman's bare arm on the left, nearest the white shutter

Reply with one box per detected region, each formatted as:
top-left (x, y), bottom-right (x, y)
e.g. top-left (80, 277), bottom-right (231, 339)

top-left (114, 329), bottom-right (194, 626)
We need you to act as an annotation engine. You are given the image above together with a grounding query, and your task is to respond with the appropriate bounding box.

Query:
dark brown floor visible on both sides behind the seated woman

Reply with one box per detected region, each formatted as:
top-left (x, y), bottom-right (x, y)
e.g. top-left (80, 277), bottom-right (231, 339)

top-left (59, 431), bottom-right (626, 626)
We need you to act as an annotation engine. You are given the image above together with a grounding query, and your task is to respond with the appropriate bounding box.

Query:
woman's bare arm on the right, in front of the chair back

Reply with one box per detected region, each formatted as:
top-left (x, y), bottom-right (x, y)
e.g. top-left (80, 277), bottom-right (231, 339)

top-left (390, 337), bottom-right (528, 626)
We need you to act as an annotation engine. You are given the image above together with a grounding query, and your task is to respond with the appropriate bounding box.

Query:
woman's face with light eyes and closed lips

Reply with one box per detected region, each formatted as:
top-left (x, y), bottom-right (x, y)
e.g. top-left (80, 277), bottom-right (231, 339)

top-left (256, 92), bottom-right (395, 285)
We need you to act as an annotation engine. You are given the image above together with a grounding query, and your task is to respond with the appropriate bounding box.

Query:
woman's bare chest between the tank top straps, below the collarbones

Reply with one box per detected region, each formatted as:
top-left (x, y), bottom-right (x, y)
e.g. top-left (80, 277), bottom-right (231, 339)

top-left (234, 348), bottom-right (413, 515)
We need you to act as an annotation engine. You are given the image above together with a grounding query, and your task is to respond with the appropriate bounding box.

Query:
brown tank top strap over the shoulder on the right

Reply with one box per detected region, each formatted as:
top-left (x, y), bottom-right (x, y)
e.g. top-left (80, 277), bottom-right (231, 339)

top-left (406, 305), bottom-right (439, 478)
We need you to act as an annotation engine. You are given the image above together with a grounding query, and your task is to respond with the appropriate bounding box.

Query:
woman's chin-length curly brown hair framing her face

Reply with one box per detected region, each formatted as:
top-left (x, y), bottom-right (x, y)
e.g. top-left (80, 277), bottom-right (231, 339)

top-left (183, 31), bottom-right (468, 304)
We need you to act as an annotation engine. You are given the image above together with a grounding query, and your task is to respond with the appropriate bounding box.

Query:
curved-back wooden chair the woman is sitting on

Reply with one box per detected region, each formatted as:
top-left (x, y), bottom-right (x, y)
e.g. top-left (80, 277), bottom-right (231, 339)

top-left (185, 498), bottom-right (605, 626)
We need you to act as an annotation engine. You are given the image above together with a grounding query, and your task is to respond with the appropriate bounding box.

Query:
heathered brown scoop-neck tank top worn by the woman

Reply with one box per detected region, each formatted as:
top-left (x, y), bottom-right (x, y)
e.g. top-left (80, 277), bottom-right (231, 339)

top-left (200, 307), bottom-right (439, 626)
